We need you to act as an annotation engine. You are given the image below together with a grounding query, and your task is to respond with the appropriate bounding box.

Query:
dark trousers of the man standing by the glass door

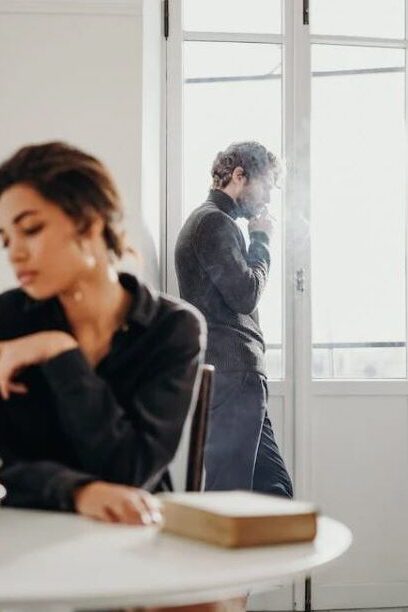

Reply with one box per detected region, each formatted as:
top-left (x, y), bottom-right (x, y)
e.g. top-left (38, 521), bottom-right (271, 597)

top-left (205, 371), bottom-right (293, 497)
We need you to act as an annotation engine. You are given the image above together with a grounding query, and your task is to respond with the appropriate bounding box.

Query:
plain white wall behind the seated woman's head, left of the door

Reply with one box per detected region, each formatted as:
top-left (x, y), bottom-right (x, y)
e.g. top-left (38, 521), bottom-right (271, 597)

top-left (0, 0), bottom-right (161, 290)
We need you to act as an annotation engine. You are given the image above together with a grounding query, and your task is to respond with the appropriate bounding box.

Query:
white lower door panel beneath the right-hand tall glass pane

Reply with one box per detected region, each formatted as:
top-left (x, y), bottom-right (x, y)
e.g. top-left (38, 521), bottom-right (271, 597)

top-left (310, 394), bottom-right (408, 610)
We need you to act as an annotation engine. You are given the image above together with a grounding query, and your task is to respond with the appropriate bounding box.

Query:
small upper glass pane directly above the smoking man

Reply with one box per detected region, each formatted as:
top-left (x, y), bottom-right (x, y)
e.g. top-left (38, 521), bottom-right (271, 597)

top-left (183, 0), bottom-right (281, 34)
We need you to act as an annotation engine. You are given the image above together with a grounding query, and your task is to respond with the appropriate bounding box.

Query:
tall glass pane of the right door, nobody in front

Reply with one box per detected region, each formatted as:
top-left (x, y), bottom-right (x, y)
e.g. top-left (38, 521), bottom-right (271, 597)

top-left (311, 45), bottom-right (406, 378)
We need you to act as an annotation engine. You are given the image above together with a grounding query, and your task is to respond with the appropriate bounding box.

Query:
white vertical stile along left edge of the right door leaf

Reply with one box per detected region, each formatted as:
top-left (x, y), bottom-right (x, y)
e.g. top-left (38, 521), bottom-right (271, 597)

top-left (285, 0), bottom-right (311, 607)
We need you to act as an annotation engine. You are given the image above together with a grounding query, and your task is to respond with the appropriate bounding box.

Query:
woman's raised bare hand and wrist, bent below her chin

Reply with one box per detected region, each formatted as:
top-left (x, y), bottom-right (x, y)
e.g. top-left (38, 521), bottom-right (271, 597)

top-left (0, 331), bottom-right (78, 400)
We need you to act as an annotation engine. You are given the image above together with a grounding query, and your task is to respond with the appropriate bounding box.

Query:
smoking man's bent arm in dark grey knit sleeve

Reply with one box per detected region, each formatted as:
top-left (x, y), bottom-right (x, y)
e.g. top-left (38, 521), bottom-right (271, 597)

top-left (194, 213), bottom-right (270, 314)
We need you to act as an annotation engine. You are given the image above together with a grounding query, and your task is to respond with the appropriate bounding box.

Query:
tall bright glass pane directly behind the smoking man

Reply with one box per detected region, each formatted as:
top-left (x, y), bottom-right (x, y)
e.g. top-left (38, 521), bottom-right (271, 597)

top-left (184, 42), bottom-right (282, 378)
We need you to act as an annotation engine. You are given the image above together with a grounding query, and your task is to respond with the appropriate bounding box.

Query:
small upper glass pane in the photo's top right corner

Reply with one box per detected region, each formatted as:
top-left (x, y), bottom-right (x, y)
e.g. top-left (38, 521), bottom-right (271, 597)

top-left (310, 0), bottom-right (405, 38)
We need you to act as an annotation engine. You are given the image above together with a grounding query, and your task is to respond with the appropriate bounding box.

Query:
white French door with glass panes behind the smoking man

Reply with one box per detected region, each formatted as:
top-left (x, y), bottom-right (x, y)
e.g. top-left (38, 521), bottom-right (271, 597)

top-left (166, 0), bottom-right (408, 610)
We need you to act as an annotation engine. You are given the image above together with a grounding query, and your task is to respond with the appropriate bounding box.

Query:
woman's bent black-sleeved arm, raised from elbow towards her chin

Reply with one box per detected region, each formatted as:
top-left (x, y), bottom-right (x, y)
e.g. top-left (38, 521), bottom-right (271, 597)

top-left (41, 308), bottom-right (204, 491)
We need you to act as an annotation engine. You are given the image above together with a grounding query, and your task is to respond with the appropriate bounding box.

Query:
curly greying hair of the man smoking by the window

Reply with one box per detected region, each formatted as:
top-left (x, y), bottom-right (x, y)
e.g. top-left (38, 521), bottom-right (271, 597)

top-left (211, 141), bottom-right (282, 189)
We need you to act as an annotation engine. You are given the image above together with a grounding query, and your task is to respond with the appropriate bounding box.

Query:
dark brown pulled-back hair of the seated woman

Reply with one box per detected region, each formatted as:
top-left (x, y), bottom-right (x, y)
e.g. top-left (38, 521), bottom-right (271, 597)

top-left (0, 142), bottom-right (126, 258)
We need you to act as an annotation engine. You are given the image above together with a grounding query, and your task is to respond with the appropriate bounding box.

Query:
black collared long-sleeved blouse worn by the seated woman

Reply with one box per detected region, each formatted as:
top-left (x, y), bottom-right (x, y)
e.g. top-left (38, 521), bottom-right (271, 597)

top-left (0, 274), bottom-right (205, 511)
